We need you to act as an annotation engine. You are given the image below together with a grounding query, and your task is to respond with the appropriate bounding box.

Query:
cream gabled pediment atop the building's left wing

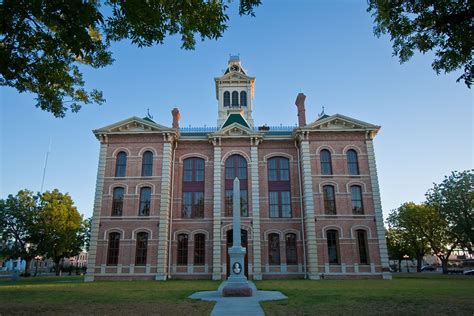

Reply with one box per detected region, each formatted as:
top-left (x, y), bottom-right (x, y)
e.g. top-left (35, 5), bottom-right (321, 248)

top-left (93, 116), bottom-right (174, 135)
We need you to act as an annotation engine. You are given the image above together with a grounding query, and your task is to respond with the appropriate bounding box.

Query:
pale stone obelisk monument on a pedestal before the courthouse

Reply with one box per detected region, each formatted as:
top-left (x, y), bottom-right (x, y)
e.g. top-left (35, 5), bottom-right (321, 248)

top-left (222, 178), bottom-right (253, 296)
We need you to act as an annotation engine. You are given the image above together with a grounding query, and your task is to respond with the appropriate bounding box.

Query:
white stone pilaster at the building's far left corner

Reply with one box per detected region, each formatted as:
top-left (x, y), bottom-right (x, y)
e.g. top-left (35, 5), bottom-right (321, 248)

top-left (84, 139), bottom-right (107, 282)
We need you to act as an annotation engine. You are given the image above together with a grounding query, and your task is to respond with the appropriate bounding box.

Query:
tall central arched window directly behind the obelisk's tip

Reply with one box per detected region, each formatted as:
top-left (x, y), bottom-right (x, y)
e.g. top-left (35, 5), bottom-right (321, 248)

top-left (225, 155), bottom-right (249, 216)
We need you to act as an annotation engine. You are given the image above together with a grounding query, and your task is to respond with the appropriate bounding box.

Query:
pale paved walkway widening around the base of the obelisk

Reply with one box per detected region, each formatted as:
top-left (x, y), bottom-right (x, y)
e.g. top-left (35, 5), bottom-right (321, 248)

top-left (189, 282), bottom-right (287, 316)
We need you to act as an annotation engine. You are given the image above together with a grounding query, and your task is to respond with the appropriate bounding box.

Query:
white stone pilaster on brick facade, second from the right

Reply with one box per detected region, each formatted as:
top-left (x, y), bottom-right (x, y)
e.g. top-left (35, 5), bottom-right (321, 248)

top-left (300, 140), bottom-right (319, 280)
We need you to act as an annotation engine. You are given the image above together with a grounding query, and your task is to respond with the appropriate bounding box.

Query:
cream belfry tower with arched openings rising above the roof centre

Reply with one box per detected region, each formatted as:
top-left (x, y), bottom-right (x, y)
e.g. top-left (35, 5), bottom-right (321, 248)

top-left (214, 56), bottom-right (255, 128)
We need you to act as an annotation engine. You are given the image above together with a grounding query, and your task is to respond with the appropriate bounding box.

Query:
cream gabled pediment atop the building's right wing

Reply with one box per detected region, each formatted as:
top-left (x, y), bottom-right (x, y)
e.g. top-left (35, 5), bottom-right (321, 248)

top-left (304, 114), bottom-right (380, 131)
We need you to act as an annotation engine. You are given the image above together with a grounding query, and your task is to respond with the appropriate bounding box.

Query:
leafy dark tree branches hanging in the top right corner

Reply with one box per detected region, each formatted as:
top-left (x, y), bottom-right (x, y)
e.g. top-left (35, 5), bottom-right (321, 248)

top-left (367, 0), bottom-right (474, 88)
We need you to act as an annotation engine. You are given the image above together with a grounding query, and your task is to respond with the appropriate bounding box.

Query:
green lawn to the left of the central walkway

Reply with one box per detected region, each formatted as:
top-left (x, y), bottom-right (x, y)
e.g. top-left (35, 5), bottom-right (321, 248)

top-left (0, 277), bottom-right (219, 316)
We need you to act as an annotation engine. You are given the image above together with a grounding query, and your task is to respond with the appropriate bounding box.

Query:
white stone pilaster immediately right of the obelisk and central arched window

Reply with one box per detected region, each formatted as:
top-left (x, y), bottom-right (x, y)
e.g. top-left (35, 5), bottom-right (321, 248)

top-left (250, 146), bottom-right (262, 280)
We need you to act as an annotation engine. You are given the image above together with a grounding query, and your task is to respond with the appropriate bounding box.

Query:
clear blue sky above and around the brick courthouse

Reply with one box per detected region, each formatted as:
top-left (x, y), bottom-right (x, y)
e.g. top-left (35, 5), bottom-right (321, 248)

top-left (0, 1), bottom-right (473, 220)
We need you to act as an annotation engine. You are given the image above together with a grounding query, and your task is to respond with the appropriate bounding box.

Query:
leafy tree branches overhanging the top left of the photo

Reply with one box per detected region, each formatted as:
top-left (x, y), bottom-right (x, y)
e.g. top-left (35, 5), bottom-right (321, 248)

top-left (0, 0), bottom-right (260, 117)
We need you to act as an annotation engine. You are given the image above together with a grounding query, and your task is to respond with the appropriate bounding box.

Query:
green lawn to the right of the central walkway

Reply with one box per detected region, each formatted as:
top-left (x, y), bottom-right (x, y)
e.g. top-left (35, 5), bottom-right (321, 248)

top-left (257, 273), bottom-right (474, 316)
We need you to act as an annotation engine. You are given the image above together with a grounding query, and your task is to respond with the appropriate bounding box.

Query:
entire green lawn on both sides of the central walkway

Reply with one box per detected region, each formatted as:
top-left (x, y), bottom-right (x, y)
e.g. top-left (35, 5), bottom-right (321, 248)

top-left (0, 273), bottom-right (474, 316)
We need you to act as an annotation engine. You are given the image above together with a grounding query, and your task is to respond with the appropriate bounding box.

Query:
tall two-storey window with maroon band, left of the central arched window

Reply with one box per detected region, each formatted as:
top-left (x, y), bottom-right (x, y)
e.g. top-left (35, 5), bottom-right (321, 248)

top-left (182, 158), bottom-right (204, 218)
